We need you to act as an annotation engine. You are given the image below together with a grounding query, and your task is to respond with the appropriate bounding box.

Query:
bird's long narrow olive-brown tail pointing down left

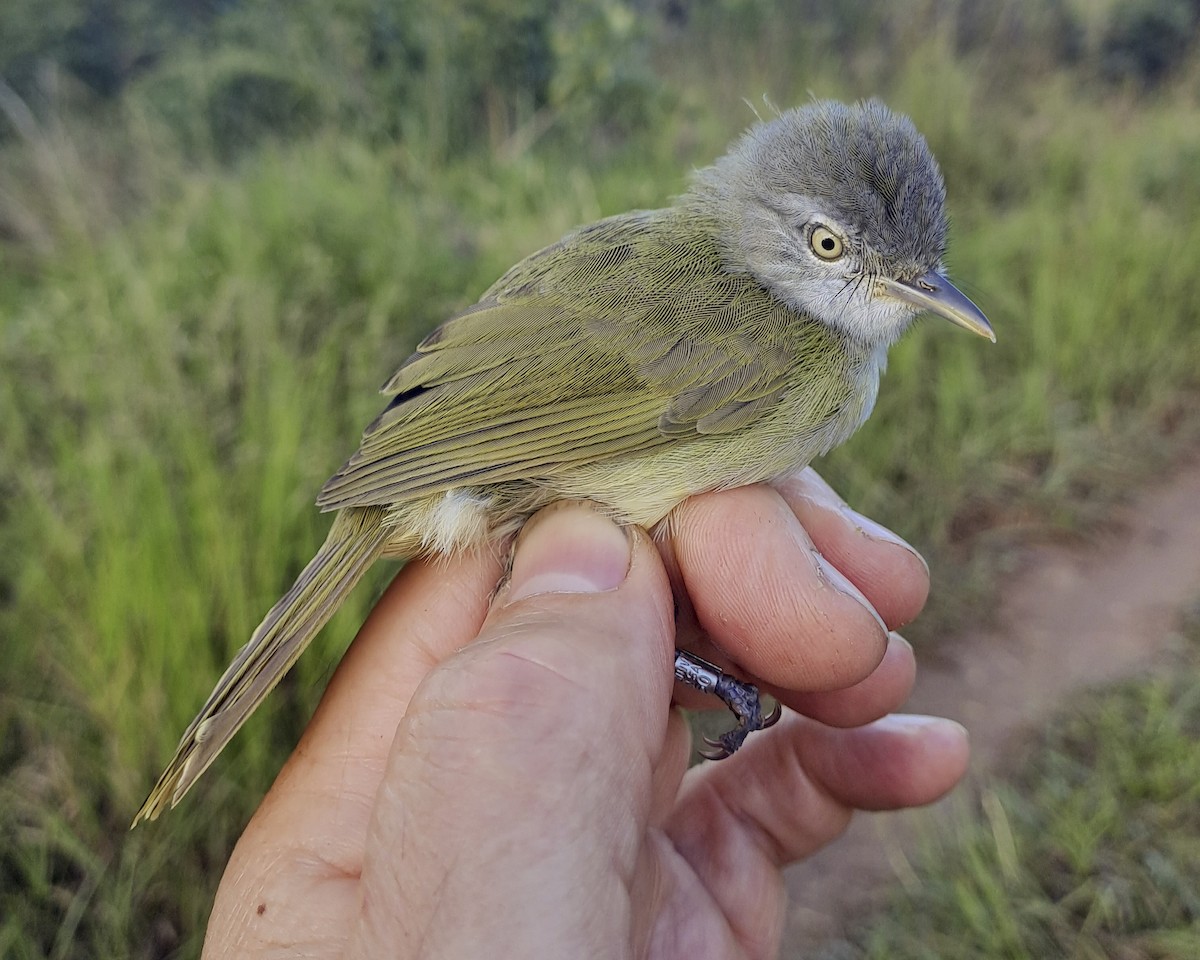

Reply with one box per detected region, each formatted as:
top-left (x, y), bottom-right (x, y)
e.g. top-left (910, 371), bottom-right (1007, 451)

top-left (133, 506), bottom-right (389, 826)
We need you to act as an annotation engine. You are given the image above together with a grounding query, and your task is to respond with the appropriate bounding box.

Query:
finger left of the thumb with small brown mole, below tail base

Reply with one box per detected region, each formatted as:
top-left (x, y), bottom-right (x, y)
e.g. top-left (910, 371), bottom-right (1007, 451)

top-left (206, 553), bottom-right (500, 956)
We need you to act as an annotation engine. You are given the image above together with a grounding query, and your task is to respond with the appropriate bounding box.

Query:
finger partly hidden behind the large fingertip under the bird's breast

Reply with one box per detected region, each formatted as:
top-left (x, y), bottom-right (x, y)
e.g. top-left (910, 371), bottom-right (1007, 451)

top-left (772, 467), bottom-right (929, 630)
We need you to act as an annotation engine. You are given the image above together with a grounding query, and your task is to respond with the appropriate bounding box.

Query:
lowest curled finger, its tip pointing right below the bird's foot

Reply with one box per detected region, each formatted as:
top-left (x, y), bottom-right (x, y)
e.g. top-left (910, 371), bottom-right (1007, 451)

top-left (668, 714), bottom-right (967, 956)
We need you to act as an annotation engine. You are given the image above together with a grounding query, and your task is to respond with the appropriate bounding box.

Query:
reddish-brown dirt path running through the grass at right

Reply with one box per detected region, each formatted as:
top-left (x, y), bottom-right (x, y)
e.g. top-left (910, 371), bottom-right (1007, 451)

top-left (784, 461), bottom-right (1200, 958)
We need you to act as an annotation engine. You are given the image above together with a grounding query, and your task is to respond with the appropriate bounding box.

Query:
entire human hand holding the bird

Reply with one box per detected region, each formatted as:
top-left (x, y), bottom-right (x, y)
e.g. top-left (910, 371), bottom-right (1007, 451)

top-left (204, 470), bottom-right (967, 960)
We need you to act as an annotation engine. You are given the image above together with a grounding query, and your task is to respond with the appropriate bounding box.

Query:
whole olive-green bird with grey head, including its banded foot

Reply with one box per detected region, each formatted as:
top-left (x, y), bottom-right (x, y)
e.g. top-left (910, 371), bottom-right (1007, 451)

top-left (134, 100), bottom-right (995, 824)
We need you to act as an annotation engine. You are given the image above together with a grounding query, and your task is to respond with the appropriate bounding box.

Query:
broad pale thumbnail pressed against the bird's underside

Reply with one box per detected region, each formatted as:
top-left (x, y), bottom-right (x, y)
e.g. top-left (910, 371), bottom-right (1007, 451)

top-left (508, 502), bottom-right (630, 602)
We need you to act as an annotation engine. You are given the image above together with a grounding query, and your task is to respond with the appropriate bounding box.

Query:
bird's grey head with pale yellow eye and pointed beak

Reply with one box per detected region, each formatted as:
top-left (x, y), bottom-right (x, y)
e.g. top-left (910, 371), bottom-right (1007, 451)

top-left (689, 100), bottom-right (991, 347)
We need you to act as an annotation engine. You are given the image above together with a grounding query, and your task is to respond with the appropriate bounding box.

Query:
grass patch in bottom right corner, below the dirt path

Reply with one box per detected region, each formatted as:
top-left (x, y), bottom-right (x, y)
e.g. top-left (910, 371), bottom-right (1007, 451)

top-left (818, 607), bottom-right (1200, 960)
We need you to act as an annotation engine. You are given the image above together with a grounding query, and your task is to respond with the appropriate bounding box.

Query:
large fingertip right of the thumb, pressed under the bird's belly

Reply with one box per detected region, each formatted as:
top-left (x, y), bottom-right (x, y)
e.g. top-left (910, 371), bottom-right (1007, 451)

top-left (671, 486), bottom-right (888, 690)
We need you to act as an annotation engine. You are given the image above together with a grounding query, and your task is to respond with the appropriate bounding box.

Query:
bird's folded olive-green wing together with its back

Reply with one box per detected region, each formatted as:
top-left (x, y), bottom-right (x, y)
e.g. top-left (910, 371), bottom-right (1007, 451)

top-left (318, 210), bottom-right (811, 510)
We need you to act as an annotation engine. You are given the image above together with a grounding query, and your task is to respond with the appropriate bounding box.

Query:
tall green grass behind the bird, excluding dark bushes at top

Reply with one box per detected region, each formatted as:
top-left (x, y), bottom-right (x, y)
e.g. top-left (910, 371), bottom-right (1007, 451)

top-left (7, 11), bottom-right (1200, 958)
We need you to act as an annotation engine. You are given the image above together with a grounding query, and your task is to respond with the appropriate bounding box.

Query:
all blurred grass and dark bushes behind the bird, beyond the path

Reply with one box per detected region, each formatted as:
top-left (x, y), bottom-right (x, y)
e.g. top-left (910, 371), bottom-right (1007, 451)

top-left (7, 0), bottom-right (1200, 958)
